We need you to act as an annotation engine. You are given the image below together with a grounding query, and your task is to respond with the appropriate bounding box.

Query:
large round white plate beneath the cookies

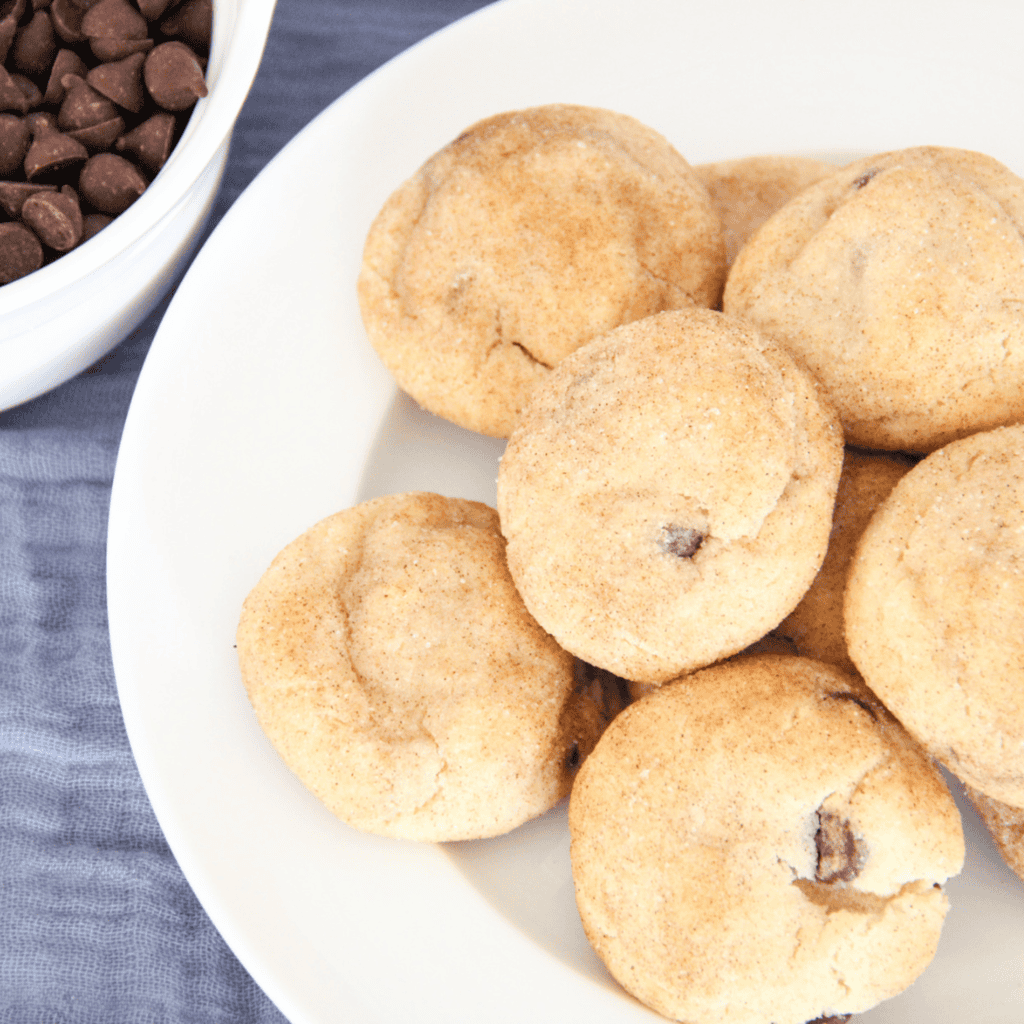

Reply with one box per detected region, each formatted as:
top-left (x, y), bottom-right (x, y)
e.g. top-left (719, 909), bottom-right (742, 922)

top-left (109, 0), bottom-right (1024, 1024)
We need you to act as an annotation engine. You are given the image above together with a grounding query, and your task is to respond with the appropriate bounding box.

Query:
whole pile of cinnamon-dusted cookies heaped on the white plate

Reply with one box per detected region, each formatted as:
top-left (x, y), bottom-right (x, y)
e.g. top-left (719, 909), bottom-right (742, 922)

top-left (239, 104), bottom-right (1024, 1024)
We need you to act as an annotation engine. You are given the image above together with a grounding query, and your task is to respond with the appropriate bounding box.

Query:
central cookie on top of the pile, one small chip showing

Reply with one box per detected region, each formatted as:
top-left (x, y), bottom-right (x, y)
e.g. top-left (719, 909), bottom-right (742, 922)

top-left (498, 309), bottom-right (843, 683)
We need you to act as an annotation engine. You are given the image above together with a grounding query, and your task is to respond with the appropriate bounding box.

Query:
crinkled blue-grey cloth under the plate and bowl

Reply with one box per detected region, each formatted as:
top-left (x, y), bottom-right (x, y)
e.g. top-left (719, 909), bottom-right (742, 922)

top-left (0, 0), bottom-right (491, 1024)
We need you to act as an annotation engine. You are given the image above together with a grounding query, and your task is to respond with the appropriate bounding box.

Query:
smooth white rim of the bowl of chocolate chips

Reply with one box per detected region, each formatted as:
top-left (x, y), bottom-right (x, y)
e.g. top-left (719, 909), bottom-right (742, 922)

top-left (0, 0), bottom-right (276, 317)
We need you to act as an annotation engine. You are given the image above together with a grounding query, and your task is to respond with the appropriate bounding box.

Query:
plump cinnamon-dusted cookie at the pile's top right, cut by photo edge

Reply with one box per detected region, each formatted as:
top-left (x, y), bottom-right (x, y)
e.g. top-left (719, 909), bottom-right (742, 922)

top-left (723, 146), bottom-right (1024, 452)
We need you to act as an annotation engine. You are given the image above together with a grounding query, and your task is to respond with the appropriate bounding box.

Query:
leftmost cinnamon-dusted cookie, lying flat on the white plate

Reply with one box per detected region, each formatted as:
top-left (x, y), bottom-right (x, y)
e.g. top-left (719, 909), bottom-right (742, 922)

top-left (238, 494), bottom-right (605, 841)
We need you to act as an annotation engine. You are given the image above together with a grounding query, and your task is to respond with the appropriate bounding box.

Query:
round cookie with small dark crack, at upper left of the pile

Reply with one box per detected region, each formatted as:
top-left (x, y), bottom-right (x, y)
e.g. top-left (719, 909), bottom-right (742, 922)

top-left (358, 104), bottom-right (725, 437)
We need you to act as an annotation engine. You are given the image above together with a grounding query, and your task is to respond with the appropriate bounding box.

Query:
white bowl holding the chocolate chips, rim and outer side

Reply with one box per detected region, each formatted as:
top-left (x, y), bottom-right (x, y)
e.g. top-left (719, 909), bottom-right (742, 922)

top-left (0, 0), bottom-right (275, 410)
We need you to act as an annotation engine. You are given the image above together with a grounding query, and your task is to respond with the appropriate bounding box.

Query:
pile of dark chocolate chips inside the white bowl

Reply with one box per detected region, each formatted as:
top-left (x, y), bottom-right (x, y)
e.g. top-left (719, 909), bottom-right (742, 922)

top-left (0, 0), bottom-right (213, 285)
